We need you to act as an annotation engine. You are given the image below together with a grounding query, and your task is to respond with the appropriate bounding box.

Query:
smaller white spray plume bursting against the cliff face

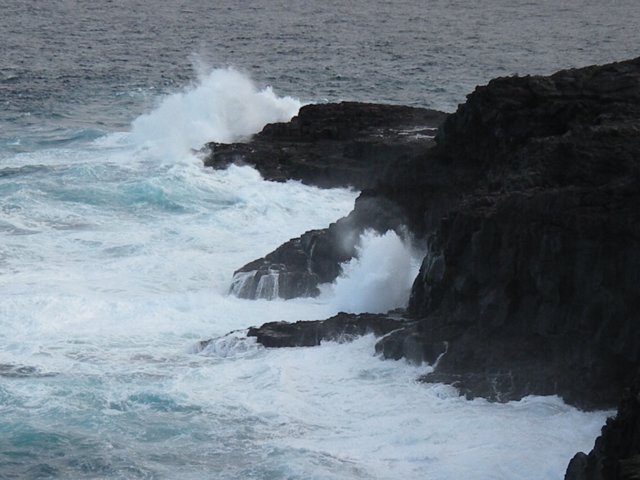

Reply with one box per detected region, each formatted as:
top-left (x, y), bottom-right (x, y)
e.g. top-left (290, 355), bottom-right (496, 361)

top-left (331, 231), bottom-right (419, 313)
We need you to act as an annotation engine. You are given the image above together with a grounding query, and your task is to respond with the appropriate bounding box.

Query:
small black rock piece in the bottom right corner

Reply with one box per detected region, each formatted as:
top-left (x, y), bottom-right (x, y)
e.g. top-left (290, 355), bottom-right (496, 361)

top-left (564, 378), bottom-right (640, 480)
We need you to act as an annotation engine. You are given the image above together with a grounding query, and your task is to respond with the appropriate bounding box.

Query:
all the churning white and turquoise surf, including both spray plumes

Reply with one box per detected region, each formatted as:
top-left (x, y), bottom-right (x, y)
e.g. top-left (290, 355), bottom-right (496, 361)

top-left (0, 70), bottom-right (606, 480)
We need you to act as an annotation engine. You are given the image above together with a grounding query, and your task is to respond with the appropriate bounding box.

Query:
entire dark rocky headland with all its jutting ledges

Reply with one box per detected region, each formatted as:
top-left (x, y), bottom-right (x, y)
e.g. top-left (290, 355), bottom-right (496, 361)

top-left (201, 58), bottom-right (640, 479)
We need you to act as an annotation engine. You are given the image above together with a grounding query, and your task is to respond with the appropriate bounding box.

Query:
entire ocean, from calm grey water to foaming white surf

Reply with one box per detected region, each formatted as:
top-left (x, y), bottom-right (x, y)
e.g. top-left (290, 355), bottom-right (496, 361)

top-left (0, 0), bottom-right (640, 480)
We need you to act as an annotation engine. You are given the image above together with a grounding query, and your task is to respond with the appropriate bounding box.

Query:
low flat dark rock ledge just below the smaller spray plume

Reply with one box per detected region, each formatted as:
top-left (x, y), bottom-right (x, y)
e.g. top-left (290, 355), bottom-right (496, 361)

top-left (247, 313), bottom-right (405, 347)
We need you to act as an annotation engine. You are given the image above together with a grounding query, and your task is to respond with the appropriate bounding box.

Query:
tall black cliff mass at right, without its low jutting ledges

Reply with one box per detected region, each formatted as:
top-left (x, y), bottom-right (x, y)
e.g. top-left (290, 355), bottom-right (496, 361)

top-left (364, 59), bottom-right (640, 408)
